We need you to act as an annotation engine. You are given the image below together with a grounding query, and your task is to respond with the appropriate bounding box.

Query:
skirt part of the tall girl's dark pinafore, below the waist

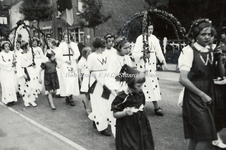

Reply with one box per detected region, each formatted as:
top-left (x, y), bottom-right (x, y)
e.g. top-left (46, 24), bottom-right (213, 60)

top-left (183, 81), bottom-right (217, 142)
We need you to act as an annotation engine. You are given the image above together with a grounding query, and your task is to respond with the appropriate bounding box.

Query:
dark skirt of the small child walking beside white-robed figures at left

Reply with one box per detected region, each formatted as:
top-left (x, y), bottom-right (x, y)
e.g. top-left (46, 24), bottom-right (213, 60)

top-left (44, 73), bottom-right (59, 91)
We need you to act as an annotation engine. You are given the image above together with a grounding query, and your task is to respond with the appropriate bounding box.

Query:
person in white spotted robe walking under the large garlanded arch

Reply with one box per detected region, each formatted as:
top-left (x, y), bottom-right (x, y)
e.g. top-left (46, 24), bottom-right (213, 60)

top-left (132, 24), bottom-right (167, 116)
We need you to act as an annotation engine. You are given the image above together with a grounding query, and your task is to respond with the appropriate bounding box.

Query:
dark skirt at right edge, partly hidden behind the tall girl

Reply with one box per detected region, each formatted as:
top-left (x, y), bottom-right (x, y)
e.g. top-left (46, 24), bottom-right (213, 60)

top-left (214, 85), bottom-right (226, 131)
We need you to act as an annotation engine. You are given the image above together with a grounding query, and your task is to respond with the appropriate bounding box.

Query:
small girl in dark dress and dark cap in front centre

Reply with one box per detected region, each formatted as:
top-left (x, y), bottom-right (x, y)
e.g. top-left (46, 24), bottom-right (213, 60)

top-left (112, 65), bottom-right (154, 150)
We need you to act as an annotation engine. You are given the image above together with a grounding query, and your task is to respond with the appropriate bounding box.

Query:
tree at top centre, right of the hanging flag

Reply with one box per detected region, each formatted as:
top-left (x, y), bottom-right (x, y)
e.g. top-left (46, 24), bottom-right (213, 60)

top-left (79, 0), bottom-right (111, 35)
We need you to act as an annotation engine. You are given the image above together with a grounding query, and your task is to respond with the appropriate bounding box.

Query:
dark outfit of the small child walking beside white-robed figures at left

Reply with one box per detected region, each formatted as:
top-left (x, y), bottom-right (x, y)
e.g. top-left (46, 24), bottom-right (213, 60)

top-left (41, 61), bottom-right (59, 91)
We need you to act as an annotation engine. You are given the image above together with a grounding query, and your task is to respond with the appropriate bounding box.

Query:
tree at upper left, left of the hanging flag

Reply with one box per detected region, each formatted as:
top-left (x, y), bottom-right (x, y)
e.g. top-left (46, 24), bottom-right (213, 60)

top-left (20, 0), bottom-right (54, 34)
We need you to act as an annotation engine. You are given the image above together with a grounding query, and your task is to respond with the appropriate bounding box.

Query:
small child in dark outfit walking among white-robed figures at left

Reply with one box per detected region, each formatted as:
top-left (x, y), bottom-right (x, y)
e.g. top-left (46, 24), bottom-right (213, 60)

top-left (39, 51), bottom-right (59, 110)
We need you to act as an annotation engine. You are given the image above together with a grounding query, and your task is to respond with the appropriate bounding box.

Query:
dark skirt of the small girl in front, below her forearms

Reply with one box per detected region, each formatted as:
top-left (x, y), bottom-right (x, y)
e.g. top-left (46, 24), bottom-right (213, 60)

top-left (115, 112), bottom-right (155, 150)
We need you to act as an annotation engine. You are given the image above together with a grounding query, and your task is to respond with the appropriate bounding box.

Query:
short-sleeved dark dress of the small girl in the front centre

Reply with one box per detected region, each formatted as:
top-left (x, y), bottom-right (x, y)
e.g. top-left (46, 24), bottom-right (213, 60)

top-left (112, 91), bottom-right (154, 150)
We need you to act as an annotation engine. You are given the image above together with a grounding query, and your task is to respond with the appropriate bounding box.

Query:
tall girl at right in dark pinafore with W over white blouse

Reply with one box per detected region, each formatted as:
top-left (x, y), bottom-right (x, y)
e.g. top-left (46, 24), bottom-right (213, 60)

top-left (179, 19), bottom-right (217, 150)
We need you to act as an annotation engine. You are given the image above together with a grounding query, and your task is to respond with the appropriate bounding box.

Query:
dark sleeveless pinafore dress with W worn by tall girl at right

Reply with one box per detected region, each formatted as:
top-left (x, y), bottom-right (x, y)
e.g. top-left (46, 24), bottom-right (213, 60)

top-left (183, 47), bottom-right (217, 142)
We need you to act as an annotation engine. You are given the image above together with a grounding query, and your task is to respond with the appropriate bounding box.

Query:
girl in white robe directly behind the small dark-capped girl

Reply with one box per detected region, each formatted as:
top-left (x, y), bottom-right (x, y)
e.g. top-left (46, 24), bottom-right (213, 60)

top-left (105, 37), bottom-right (132, 137)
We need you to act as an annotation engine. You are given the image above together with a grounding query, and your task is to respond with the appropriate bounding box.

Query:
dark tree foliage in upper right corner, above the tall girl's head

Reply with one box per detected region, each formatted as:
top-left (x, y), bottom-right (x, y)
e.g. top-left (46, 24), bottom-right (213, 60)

top-left (145, 0), bottom-right (226, 33)
